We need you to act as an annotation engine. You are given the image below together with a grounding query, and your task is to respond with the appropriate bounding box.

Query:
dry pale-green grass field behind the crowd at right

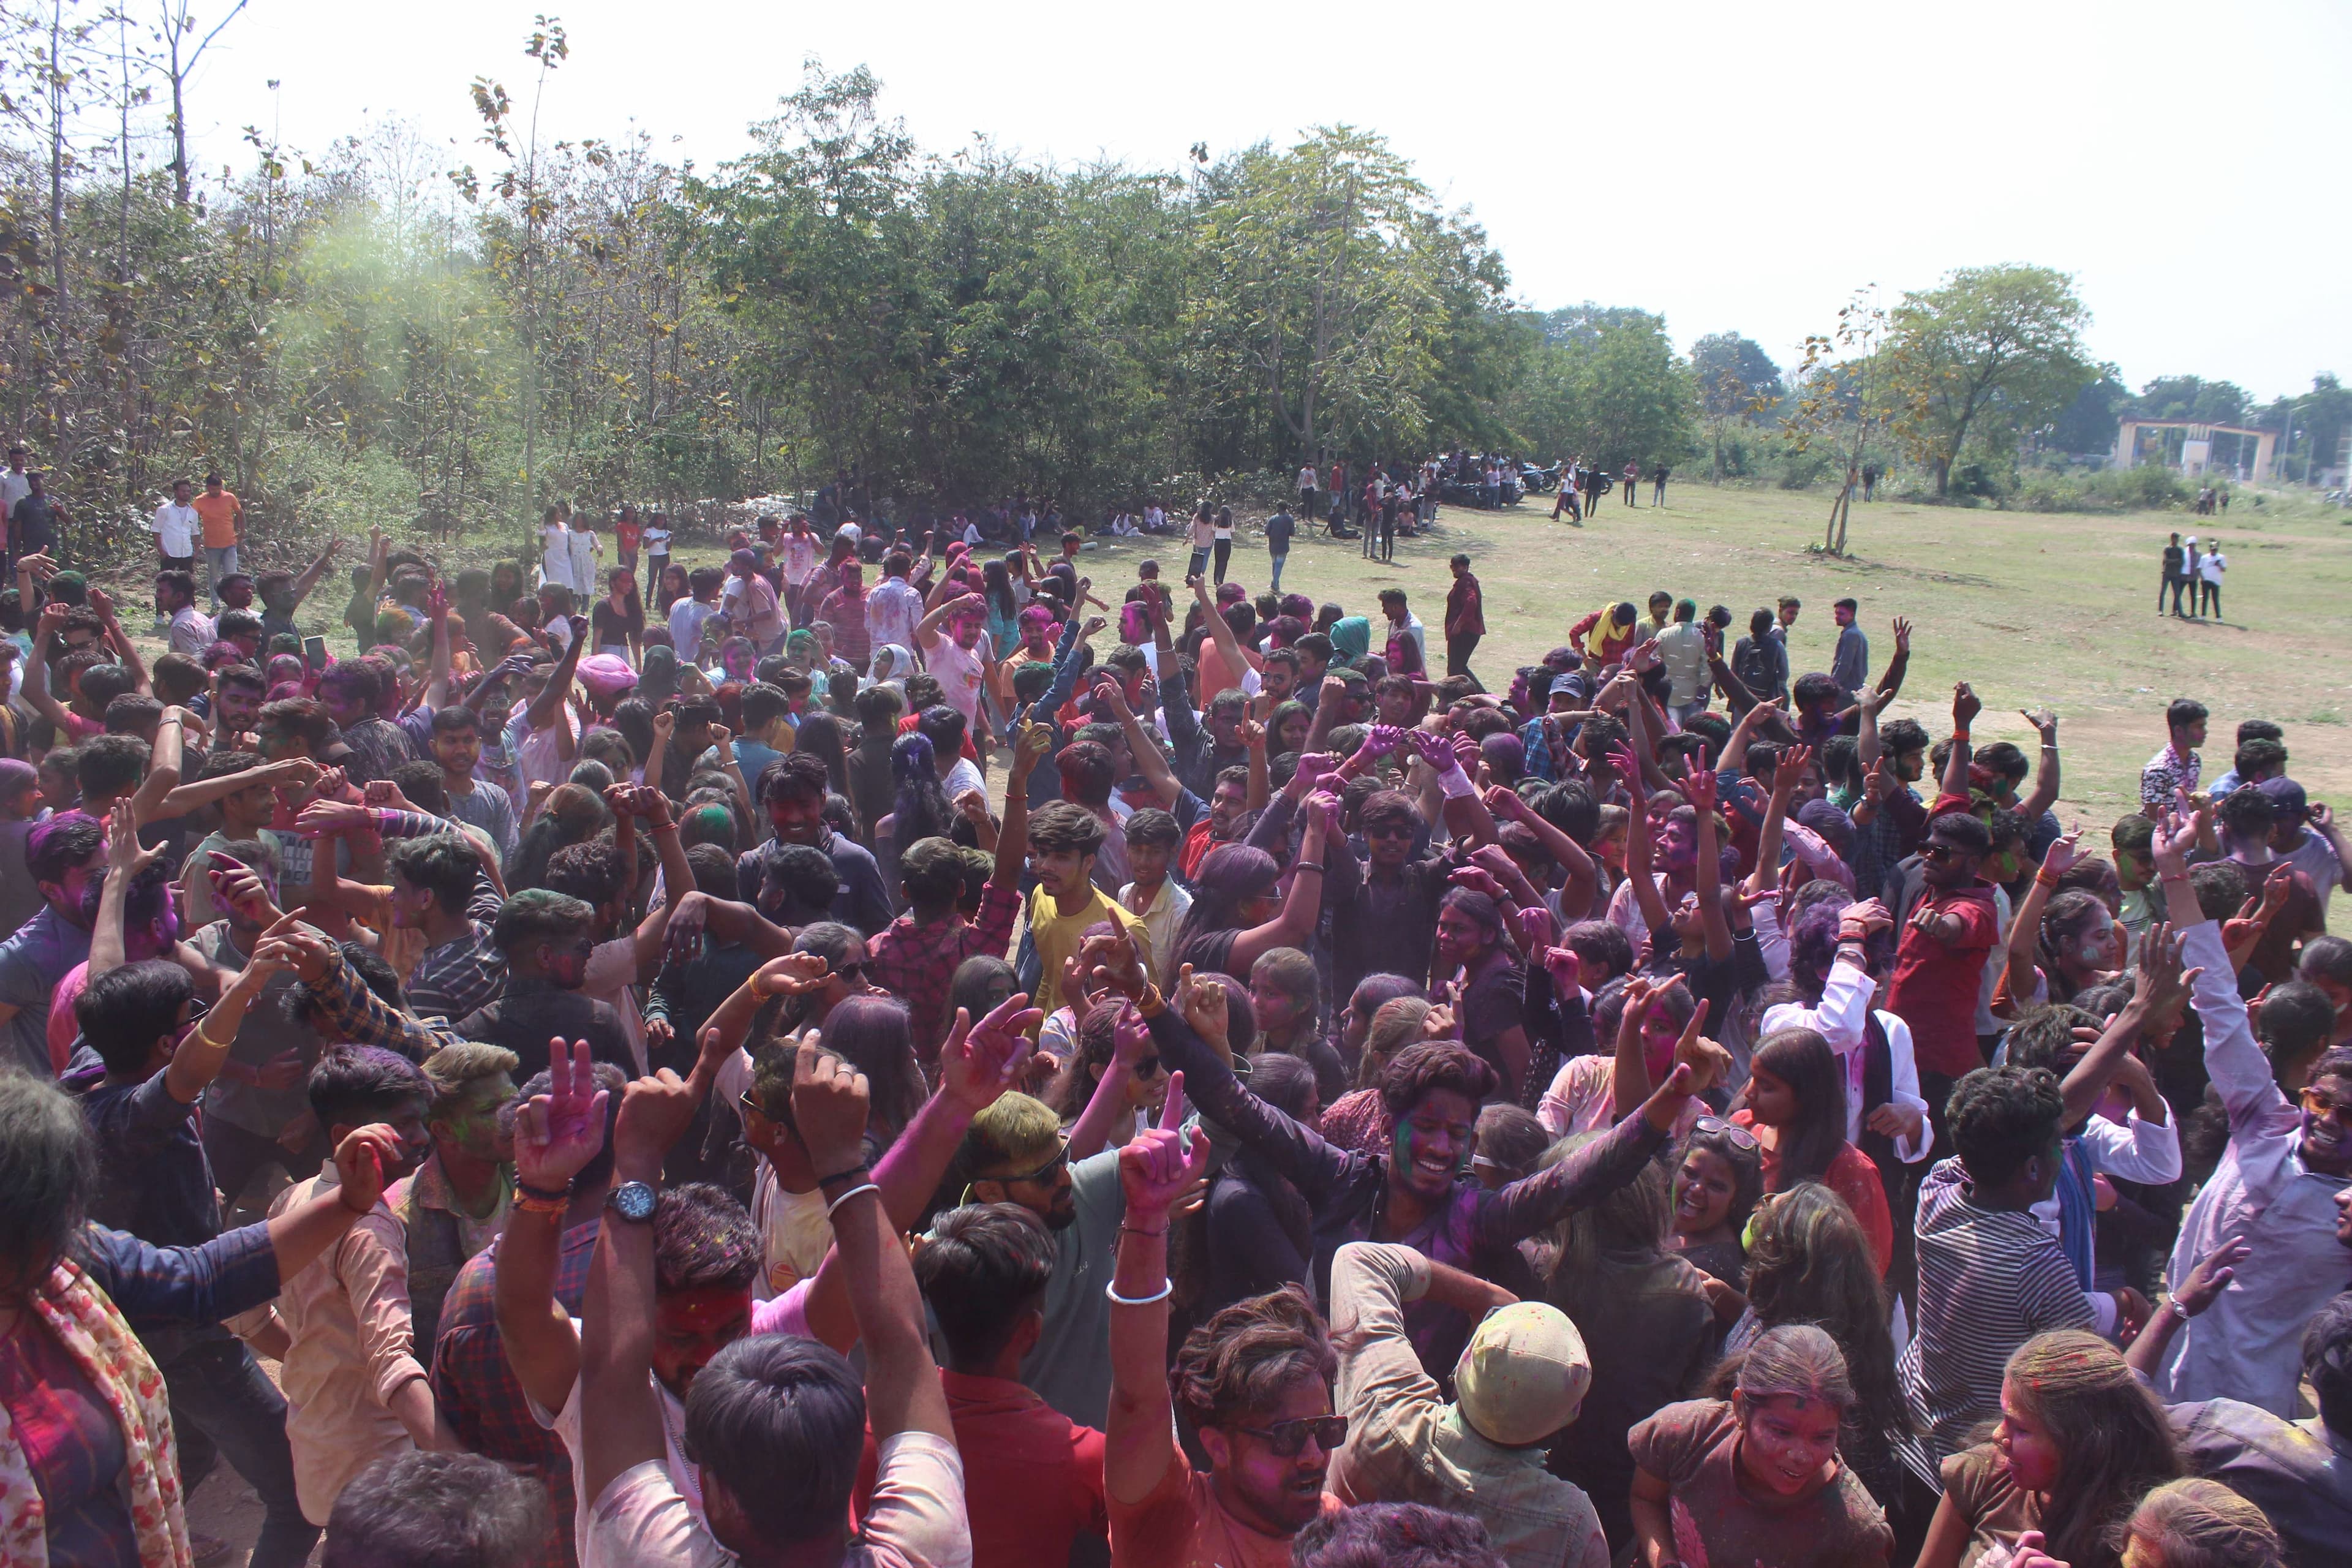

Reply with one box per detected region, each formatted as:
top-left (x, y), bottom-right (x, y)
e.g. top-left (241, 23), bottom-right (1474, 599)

top-left (1087, 484), bottom-right (2352, 825)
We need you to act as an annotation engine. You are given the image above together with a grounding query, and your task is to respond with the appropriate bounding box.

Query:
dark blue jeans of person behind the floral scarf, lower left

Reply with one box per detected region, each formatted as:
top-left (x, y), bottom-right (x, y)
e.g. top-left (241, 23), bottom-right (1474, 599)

top-left (157, 1338), bottom-right (317, 1568)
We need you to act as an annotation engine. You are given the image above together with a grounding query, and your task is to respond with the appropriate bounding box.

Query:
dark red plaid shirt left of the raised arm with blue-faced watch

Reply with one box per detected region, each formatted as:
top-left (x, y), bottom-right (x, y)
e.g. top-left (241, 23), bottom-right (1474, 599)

top-left (433, 1220), bottom-right (602, 1568)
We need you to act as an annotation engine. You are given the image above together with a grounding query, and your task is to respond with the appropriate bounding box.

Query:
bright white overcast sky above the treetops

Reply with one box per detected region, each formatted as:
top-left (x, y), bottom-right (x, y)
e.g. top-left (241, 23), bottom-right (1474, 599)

top-left (188, 0), bottom-right (2352, 399)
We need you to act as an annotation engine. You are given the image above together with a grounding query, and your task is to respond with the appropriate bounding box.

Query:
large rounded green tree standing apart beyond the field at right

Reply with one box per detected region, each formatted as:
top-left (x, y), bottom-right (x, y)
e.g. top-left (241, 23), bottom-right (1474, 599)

top-left (1884, 266), bottom-right (2100, 496)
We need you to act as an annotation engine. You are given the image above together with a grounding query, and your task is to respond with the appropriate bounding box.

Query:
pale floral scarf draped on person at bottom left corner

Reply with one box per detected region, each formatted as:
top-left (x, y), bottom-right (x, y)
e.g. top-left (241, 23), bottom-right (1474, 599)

top-left (0, 1257), bottom-right (195, 1568)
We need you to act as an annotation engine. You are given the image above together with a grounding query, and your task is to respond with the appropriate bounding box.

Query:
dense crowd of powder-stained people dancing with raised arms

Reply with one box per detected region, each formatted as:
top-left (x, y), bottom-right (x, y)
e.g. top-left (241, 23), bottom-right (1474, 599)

top-left (0, 470), bottom-right (2352, 1568)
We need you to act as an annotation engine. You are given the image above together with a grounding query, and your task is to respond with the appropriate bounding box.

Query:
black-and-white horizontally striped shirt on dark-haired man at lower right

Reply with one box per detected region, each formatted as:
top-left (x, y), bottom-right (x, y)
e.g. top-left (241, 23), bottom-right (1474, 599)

top-left (1896, 1159), bottom-right (2095, 1488)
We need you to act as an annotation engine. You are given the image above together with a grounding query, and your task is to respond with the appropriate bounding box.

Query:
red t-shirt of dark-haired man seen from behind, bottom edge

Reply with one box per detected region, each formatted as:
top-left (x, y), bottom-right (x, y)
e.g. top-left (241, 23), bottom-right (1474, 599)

top-left (851, 1368), bottom-right (1110, 1568)
